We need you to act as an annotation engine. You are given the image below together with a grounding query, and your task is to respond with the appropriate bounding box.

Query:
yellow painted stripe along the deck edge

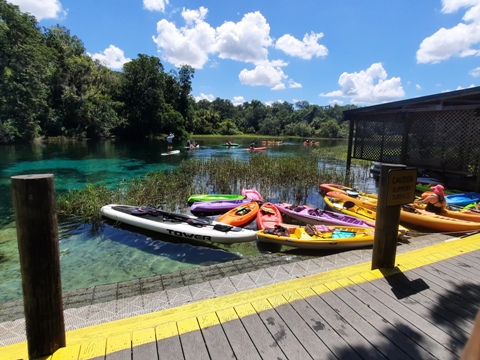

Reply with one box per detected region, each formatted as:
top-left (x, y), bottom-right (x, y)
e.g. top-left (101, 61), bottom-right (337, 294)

top-left (0, 234), bottom-right (480, 359)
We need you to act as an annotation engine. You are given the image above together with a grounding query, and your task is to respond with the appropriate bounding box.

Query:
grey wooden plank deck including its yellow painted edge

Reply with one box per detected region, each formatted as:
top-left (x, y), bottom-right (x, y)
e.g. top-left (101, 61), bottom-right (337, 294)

top-left (0, 235), bottom-right (480, 360)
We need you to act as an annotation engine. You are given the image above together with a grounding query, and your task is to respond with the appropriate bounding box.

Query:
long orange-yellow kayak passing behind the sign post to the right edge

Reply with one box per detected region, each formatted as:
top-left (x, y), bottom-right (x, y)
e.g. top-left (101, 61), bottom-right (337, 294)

top-left (327, 191), bottom-right (480, 232)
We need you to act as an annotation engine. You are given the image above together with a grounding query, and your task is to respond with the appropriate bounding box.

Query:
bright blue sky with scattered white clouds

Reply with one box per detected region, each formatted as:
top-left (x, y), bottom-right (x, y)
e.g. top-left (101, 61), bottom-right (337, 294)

top-left (7, 0), bottom-right (480, 106)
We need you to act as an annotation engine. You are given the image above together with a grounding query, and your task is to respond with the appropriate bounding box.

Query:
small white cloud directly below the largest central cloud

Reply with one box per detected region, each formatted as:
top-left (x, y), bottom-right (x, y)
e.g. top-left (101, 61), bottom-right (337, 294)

top-left (238, 61), bottom-right (287, 90)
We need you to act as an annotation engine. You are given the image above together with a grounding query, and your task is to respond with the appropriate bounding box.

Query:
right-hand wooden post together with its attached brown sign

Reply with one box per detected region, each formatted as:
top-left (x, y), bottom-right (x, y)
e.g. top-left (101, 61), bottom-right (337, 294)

top-left (372, 164), bottom-right (417, 270)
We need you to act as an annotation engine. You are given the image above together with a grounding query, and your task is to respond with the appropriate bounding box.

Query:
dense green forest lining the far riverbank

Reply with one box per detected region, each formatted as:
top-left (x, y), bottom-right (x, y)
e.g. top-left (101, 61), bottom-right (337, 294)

top-left (0, 0), bottom-right (355, 144)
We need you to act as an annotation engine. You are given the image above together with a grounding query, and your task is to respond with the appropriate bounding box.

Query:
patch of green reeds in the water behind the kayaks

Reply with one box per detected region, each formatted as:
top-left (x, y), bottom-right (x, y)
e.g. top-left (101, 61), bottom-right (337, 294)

top-left (57, 152), bottom-right (354, 222)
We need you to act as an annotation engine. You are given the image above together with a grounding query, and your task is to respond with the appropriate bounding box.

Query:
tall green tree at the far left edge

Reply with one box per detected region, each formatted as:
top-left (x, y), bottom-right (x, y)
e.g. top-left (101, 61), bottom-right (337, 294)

top-left (0, 0), bottom-right (48, 143)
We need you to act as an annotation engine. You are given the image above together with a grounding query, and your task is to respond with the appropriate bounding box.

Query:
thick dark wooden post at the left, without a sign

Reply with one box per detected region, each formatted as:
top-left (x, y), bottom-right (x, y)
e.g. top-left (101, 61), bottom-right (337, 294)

top-left (11, 174), bottom-right (65, 358)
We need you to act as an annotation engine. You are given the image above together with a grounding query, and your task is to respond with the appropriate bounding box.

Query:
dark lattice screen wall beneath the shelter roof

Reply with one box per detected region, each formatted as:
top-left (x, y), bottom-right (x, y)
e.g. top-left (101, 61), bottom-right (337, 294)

top-left (352, 110), bottom-right (480, 174)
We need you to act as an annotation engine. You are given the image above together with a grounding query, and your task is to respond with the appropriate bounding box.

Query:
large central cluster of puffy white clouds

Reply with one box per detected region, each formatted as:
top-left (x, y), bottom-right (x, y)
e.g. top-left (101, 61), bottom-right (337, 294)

top-left (152, 6), bottom-right (328, 90)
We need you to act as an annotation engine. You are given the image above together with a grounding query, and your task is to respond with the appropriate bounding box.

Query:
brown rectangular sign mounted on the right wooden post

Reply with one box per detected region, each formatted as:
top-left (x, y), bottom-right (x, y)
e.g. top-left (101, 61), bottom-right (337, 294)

top-left (386, 169), bottom-right (417, 206)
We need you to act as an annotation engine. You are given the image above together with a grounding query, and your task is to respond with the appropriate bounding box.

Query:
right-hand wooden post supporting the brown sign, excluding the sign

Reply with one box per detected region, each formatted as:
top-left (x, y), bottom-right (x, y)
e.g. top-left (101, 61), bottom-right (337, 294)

top-left (372, 164), bottom-right (405, 270)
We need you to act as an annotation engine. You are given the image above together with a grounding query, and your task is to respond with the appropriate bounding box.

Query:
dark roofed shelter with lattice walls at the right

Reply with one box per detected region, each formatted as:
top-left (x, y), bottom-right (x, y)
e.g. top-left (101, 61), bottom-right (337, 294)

top-left (343, 87), bottom-right (480, 191)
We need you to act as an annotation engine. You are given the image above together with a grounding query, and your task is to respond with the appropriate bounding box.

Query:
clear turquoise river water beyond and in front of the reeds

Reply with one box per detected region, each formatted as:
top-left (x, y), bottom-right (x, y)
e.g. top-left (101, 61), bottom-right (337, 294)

top-left (0, 139), bottom-right (374, 302)
